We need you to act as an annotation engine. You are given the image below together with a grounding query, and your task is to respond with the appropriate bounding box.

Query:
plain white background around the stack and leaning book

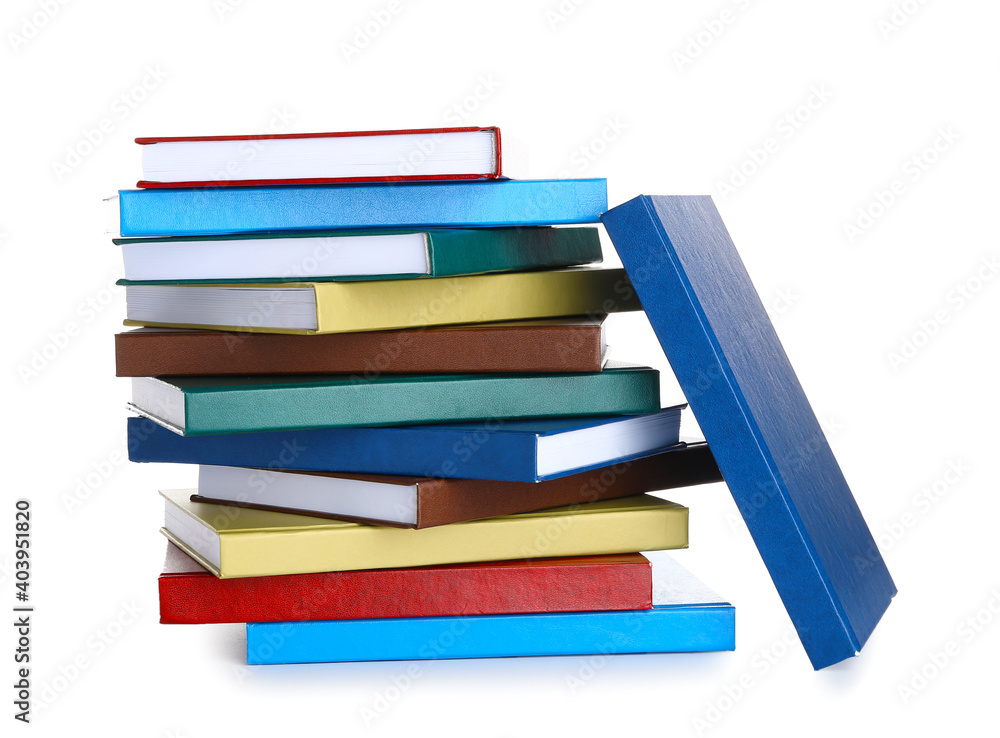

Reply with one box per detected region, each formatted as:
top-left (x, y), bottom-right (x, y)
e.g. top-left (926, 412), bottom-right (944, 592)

top-left (0, 0), bottom-right (1000, 736)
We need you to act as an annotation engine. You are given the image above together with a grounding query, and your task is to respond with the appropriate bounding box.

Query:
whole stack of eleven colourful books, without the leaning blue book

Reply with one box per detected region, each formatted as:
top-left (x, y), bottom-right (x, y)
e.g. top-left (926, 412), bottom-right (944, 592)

top-left (115, 128), bottom-right (735, 664)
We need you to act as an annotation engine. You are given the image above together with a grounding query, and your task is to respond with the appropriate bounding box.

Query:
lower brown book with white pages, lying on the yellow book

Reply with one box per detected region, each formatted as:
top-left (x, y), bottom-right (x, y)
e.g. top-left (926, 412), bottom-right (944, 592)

top-left (191, 443), bottom-right (722, 528)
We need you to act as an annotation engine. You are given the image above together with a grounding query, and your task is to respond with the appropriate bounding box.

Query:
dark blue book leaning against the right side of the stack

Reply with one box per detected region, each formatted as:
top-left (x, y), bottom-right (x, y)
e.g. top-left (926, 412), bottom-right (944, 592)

top-left (601, 196), bottom-right (896, 669)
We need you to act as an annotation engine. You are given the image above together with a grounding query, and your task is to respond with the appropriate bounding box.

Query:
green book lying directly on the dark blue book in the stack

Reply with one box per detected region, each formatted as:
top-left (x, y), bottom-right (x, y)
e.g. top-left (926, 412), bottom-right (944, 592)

top-left (131, 362), bottom-right (660, 435)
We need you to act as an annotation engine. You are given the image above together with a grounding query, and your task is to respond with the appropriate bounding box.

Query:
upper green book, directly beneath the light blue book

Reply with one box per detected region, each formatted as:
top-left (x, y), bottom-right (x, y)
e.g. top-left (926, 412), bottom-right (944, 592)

top-left (112, 226), bottom-right (601, 284)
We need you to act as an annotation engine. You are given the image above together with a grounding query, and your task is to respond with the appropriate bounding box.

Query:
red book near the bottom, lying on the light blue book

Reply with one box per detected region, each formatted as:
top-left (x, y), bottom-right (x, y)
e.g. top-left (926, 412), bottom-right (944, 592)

top-left (158, 541), bottom-right (652, 624)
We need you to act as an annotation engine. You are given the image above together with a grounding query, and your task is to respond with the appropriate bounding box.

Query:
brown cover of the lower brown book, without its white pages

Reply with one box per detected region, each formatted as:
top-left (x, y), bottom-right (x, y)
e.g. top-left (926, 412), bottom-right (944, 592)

top-left (191, 443), bottom-right (722, 528)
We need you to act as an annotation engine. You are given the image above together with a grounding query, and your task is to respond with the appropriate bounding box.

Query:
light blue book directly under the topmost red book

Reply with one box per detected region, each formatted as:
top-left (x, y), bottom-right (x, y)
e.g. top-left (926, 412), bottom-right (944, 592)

top-left (119, 179), bottom-right (608, 236)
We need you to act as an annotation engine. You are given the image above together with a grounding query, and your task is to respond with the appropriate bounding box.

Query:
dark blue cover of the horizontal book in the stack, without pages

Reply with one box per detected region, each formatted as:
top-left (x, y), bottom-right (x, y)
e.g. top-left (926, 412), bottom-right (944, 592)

top-left (128, 417), bottom-right (683, 482)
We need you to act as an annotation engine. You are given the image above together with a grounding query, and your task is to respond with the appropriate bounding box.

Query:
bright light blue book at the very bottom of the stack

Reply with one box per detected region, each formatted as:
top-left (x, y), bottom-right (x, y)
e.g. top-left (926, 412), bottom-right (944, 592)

top-left (247, 551), bottom-right (736, 664)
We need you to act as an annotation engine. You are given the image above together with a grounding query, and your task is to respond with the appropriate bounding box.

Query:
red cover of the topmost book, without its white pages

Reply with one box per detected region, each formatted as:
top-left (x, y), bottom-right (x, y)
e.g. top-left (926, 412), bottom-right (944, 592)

top-left (135, 126), bottom-right (504, 189)
